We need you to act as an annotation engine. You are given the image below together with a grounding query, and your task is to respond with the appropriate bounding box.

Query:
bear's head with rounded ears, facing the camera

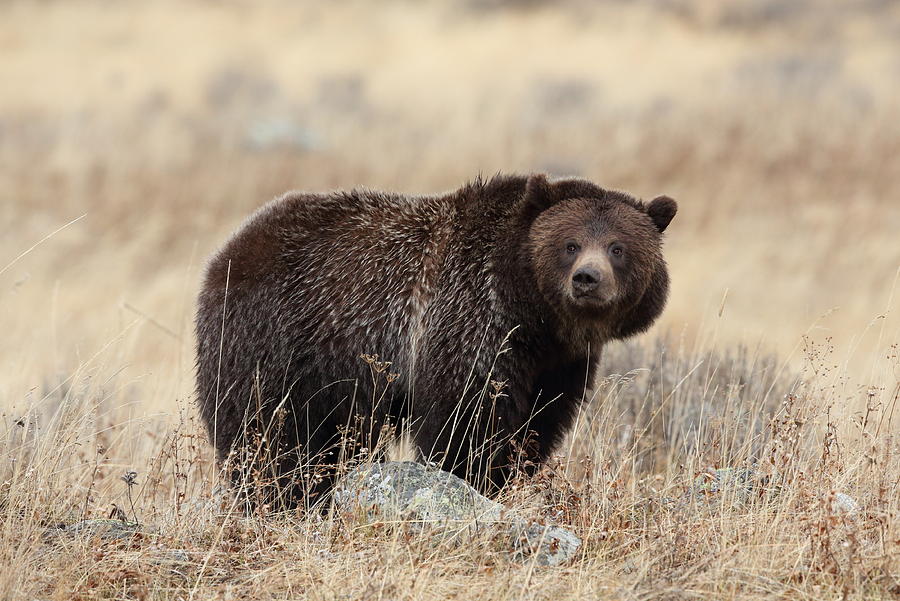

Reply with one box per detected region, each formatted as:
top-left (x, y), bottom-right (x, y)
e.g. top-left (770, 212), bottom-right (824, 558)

top-left (523, 175), bottom-right (677, 339)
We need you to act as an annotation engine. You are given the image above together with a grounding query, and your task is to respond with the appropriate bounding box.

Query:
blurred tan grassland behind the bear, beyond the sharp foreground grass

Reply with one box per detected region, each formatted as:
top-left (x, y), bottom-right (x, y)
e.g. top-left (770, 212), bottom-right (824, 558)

top-left (0, 0), bottom-right (900, 414)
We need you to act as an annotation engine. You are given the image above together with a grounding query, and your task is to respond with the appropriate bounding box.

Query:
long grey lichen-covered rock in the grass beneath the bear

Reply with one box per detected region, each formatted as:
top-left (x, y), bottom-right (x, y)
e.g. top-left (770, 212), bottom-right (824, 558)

top-left (334, 461), bottom-right (581, 566)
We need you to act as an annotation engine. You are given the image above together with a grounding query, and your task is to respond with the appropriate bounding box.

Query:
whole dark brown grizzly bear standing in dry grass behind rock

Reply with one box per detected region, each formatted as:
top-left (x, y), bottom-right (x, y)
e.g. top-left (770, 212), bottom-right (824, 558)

top-left (196, 174), bottom-right (676, 507)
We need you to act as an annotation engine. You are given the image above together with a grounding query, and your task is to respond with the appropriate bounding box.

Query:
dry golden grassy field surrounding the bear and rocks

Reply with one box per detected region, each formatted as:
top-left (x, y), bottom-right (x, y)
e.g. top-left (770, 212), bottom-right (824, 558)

top-left (0, 0), bottom-right (900, 600)
